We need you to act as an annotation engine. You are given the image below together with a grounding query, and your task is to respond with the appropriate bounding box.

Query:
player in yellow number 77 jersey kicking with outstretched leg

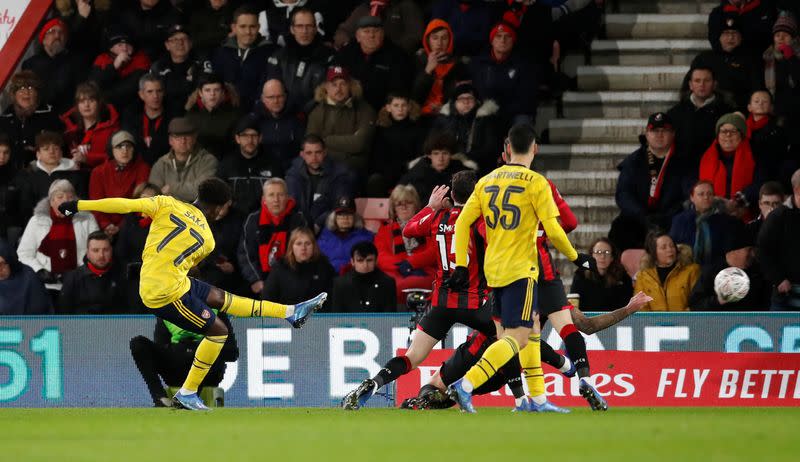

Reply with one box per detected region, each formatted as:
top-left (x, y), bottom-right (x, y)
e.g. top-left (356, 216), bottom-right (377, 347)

top-left (58, 178), bottom-right (328, 411)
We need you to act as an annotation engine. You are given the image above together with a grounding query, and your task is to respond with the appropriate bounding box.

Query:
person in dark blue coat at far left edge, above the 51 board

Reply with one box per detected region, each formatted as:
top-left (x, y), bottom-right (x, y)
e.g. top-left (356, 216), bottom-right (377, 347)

top-left (0, 239), bottom-right (53, 316)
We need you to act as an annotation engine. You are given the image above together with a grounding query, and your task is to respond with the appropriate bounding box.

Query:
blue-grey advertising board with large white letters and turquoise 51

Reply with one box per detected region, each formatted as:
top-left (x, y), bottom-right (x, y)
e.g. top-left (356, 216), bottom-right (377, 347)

top-left (0, 313), bottom-right (800, 407)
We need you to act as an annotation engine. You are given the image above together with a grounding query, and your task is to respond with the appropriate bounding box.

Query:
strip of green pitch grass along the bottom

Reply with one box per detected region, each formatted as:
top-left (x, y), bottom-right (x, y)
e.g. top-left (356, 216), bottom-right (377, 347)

top-left (0, 408), bottom-right (800, 462)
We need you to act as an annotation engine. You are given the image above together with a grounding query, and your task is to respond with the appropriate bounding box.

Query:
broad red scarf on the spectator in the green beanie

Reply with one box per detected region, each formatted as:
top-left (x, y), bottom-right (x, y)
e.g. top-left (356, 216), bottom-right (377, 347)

top-left (699, 138), bottom-right (756, 199)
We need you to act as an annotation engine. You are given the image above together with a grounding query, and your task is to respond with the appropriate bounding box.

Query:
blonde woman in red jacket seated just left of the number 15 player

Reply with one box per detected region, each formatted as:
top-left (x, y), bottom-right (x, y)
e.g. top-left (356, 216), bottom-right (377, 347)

top-left (375, 185), bottom-right (437, 301)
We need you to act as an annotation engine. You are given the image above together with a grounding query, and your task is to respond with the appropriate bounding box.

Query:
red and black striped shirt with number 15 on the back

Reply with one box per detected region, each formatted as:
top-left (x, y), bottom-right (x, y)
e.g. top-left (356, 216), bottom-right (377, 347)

top-left (403, 206), bottom-right (489, 310)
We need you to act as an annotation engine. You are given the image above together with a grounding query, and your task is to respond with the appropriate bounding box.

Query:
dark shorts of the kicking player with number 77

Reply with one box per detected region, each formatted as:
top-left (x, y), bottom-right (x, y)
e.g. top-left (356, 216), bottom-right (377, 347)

top-left (153, 278), bottom-right (217, 335)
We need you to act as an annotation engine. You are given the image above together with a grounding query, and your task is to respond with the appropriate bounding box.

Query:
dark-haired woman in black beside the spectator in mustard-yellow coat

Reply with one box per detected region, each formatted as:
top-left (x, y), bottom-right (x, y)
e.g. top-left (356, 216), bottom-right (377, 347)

top-left (570, 237), bottom-right (633, 311)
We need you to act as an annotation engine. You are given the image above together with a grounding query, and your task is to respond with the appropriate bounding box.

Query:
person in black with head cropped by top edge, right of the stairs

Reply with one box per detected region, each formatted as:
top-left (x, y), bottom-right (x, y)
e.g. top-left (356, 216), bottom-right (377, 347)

top-left (708, 0), bottom-right (776, 57)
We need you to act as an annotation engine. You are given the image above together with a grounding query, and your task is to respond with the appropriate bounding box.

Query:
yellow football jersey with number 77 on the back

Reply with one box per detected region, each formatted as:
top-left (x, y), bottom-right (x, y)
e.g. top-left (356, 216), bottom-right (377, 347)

top-left (78, 196), bottom-right (214, 308)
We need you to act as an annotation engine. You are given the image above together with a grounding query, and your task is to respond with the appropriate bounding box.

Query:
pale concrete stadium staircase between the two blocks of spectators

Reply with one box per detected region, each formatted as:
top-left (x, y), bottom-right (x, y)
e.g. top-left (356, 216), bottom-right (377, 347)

top-left (535, 0), bottom-right (719, 287)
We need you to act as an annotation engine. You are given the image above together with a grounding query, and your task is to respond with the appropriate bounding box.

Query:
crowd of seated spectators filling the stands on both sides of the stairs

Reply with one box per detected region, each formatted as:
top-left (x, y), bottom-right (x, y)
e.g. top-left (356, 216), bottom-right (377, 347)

top-left (0, 0), bottom-right (800, 314)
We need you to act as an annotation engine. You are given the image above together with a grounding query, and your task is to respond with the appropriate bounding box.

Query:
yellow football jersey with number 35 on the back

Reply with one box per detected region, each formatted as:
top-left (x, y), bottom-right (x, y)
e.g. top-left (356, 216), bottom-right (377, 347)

top-left (456, 164), bottom-right (574, 287)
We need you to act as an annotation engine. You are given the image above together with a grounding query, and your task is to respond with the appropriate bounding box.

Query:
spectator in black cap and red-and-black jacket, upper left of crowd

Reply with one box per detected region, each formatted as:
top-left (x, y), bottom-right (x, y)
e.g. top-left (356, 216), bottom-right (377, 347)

top-left (89, 27), bottom-right (150, 108)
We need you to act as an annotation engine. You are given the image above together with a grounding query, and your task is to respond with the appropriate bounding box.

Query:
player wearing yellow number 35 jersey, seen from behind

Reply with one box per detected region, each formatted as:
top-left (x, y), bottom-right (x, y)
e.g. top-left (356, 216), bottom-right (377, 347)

top-left (444, 124), bottom-right (596, 413)
